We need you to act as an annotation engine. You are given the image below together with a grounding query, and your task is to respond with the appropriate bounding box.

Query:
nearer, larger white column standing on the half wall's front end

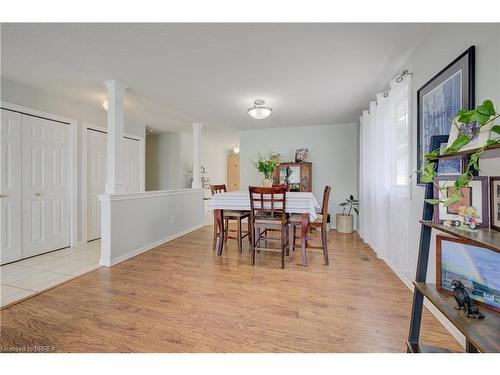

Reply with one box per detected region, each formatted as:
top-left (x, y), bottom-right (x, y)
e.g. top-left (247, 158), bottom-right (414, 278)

top-left (103, 80), bottom-right (127, 194)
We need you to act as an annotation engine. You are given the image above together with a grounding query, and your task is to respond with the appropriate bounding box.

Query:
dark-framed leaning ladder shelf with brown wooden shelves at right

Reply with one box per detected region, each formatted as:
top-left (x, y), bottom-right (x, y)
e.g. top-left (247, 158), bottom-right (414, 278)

top-left (406, 145), bottom-right (500, 353)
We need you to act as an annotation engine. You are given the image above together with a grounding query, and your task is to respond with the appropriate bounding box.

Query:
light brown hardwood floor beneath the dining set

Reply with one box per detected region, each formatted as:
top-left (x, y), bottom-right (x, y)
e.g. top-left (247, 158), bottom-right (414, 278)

top-left (1, 227), bottom-right (461, 352)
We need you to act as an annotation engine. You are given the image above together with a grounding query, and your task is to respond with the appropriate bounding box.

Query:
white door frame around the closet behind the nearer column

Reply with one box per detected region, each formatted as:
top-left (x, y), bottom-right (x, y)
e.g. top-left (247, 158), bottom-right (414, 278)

top-left (81, 122), bottom-right (146, 243)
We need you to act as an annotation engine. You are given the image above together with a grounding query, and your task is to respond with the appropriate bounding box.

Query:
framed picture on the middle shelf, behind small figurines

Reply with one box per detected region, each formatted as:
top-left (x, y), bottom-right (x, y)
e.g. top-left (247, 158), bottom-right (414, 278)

top-left (434, 176), bottom-right (490, 228)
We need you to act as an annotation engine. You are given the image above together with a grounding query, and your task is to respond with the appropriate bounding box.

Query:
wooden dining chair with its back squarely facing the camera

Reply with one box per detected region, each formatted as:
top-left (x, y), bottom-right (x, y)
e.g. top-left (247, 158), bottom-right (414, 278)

top-left (248, 186), bottom-right (289, 268)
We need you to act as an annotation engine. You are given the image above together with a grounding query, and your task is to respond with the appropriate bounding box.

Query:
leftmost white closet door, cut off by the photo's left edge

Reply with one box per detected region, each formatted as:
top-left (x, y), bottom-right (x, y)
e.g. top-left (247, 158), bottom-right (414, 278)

top-left (0, 109), bottom-right (22, 264)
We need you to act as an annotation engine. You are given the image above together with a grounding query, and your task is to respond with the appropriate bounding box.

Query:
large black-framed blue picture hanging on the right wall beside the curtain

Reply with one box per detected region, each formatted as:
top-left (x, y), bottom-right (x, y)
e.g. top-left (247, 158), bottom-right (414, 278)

top-left (417, 46), bottom-right (475, 185)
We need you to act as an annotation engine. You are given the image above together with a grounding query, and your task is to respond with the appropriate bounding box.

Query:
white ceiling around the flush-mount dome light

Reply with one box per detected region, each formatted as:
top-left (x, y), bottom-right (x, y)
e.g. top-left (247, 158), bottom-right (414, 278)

top-left (1, 24), bottom-right (432, 130)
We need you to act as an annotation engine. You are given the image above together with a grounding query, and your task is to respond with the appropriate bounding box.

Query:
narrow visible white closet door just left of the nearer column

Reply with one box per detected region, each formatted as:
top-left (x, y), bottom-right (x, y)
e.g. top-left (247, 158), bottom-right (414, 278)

top-left (87, 129), bottom-right (107, 241)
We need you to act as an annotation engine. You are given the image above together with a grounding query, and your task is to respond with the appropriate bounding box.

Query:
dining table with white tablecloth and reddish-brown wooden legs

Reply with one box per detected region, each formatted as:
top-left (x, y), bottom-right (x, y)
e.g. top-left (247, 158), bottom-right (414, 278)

top-left (208, 191), bottom-right (320, 266)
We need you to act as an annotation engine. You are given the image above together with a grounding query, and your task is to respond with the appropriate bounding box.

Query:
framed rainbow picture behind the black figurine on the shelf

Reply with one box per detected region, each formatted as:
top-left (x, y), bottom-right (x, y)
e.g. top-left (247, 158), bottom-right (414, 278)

top-left (436, 235), bottom-right (500, 312)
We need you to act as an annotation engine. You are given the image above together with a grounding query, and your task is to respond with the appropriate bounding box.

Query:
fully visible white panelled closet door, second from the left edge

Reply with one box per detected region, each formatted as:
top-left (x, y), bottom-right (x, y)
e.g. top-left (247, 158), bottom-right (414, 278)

top-left (22, 115), bottom-right (70, 258)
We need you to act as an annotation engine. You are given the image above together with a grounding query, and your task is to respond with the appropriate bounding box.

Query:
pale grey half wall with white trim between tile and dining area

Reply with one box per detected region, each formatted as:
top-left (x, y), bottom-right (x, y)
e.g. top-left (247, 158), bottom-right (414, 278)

top-left (99, 189), bottom-right (203, 267)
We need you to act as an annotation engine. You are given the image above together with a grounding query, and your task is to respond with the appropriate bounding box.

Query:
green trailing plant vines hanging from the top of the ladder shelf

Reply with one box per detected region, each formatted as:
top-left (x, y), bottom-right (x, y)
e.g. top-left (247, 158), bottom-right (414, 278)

top-left (417, 100), bottom-right (500, 207)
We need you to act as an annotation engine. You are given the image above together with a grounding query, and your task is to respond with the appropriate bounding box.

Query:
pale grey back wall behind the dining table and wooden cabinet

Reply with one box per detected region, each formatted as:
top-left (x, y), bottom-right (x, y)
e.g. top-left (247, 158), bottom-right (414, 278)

top-left (240, 124), bottom-right (359, 220)
